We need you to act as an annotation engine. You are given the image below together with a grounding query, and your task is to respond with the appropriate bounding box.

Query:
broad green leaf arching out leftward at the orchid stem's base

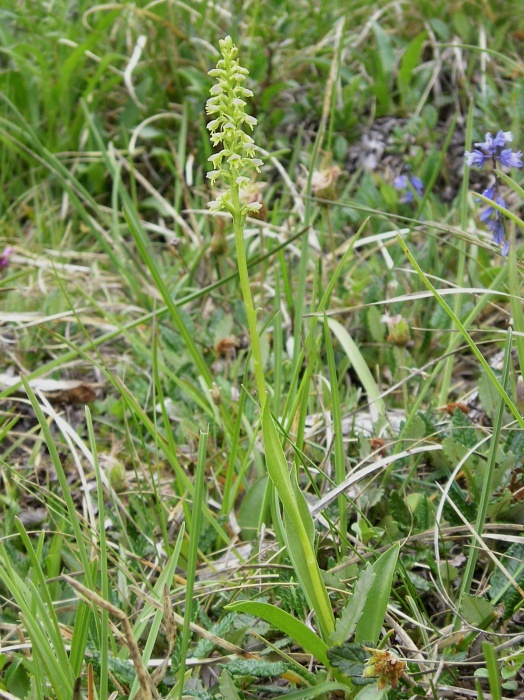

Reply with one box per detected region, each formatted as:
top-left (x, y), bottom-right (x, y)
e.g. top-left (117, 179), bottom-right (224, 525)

top-left (226, 600), bottom-right (328, 666)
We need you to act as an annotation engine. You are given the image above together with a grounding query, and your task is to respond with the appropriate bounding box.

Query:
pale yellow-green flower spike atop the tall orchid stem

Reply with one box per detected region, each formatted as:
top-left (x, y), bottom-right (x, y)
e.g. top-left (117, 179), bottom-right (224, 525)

top-left (206, 36), bottom-right (262, 216)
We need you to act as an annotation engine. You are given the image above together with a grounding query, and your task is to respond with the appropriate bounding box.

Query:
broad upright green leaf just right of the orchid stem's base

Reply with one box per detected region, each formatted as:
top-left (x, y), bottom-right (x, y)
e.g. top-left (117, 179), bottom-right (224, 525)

top-left (355, 544), bottom-right (399, 646)
